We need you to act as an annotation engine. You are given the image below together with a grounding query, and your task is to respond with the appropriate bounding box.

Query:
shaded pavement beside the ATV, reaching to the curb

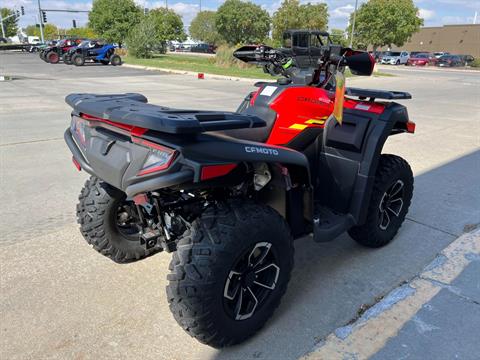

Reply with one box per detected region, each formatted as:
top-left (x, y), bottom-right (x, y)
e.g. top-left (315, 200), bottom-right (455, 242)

top-left (213, 150), bottom-right (480, 360)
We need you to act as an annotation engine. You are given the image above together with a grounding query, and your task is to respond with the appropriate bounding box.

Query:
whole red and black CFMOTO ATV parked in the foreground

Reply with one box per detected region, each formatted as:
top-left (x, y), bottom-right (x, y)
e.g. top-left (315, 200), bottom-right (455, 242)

top-left (65, 31), bottom-right (415, 347)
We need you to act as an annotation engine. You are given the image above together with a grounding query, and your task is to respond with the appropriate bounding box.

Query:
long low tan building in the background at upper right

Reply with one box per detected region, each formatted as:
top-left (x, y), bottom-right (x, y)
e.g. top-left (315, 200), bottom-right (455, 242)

top-left (376, 24), bottom-right (480, 58)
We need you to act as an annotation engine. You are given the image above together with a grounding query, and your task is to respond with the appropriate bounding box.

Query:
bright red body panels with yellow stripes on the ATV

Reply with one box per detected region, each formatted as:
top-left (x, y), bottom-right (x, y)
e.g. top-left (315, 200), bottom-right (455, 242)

top-left (264, 86), bottom-right (385, 145)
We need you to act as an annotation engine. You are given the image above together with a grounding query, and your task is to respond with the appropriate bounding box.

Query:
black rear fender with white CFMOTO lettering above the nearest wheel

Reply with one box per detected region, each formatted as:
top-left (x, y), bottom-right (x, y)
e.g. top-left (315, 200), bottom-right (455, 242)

top-left (181, 135), bottom-right (313, 237)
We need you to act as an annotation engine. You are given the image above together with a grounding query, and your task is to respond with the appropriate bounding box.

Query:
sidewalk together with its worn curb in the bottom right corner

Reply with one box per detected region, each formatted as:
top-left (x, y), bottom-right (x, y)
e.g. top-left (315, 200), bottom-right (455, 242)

top-left (304, 230), bottom-right (480, 360)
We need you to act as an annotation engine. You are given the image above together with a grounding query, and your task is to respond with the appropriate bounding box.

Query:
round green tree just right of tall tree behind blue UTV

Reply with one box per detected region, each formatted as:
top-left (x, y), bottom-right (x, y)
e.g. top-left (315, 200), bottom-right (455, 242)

top-left (147, 8), bottom-right (187, 45)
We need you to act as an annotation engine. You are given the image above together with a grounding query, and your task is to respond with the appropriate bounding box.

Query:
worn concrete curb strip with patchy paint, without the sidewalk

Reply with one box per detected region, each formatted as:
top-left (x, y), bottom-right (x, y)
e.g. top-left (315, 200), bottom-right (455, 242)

top-left (302, 229), bottom-right (480, 360)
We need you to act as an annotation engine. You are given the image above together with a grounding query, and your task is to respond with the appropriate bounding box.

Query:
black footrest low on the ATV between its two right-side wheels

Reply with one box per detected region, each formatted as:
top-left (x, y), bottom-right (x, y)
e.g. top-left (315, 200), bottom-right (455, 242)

top-left (313, 207), bottom-right (354, 242)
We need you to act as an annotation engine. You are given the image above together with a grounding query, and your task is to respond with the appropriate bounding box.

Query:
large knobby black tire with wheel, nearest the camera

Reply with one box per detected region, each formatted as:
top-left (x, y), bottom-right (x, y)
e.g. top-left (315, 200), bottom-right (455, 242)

top-left (167, 200), bottom-right (294, 348)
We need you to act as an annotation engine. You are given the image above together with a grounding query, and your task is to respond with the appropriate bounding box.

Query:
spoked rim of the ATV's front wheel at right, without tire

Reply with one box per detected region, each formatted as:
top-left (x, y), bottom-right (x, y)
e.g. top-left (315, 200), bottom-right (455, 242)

top-left (378, 180), bottom-right (405, 231)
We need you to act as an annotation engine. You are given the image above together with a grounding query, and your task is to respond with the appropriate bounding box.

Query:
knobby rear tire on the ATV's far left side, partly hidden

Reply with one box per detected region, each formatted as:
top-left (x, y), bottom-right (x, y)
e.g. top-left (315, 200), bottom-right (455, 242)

top-left (77, 176), bottom-right (162, 263)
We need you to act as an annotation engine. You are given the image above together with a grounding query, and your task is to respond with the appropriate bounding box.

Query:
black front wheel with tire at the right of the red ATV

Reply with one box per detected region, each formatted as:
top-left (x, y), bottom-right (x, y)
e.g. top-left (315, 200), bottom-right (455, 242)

top-left (348, 155), bottom-right (413, 248)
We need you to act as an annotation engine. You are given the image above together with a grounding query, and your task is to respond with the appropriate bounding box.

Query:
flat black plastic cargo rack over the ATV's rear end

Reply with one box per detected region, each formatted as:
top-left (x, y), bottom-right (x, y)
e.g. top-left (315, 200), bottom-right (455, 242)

top-left (65, 93), bottom-right (266, 134)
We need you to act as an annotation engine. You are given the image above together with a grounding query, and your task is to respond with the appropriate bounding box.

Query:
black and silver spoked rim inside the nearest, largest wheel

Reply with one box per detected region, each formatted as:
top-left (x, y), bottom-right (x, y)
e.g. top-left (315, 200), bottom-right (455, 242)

top-left (223, 242), bottom-right (280, 321)
